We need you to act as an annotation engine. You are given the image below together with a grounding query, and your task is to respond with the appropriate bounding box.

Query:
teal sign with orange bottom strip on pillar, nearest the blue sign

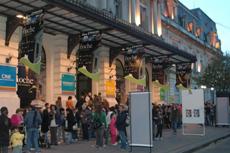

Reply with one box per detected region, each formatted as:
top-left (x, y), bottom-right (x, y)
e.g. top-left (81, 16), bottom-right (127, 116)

top-left (61, 74), bottom-right (76, 95)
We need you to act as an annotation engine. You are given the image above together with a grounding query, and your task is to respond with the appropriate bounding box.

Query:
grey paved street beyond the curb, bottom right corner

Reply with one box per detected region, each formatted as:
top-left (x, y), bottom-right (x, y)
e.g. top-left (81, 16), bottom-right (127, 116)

top-left (195, 138), bottom-right (230, 153)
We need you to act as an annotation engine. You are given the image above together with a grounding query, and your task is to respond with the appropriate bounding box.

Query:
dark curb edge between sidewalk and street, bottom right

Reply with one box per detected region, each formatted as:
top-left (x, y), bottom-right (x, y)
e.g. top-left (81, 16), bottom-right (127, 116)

top-left (182, 133), bottom-right (230, 153)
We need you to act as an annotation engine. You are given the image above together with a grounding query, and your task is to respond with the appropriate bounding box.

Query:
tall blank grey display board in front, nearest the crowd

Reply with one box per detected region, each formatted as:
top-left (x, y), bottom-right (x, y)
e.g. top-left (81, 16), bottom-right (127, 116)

top-left (129, 92), bottom-right (153, 147)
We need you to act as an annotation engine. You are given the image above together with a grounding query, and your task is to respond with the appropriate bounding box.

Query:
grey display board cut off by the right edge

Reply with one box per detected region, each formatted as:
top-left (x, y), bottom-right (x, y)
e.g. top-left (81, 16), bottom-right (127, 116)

top-left (216, 97), bottom-right (230, 125)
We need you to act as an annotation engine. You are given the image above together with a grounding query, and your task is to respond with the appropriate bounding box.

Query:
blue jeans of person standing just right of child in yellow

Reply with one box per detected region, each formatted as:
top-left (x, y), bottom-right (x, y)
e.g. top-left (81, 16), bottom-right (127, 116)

top-left (26, 128), bottom-right (40, 152)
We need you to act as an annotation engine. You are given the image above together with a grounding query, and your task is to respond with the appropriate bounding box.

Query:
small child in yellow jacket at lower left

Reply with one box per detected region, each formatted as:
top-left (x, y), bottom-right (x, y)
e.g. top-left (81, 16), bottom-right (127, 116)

top-left (10, 128), bottom-right (24, 153)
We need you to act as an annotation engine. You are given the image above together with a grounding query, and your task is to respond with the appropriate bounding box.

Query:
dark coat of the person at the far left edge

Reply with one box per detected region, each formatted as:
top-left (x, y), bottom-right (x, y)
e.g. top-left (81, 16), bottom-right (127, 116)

top-left (0, 115), bottom-right (10, 146)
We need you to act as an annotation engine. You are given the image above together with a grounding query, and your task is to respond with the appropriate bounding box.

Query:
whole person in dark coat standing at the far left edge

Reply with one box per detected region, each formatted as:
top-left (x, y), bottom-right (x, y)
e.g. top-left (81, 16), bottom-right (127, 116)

top-left (0, 107), bottom-right (10, 153)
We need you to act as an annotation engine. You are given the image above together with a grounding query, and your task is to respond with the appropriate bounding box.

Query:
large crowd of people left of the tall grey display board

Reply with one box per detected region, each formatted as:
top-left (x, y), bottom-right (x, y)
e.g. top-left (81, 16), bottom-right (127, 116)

top-left (0, 93), bottom-right (128, 153)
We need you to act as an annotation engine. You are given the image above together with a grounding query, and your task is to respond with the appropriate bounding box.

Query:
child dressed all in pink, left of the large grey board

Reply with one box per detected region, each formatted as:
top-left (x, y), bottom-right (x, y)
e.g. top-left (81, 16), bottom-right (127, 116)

top-left (109, 113), bottom-right (117, 145)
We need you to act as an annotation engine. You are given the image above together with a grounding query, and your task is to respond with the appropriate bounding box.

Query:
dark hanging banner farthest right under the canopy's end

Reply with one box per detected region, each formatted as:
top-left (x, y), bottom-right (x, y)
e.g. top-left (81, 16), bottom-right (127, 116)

top-left (176, 63), bottom-right (191, 88)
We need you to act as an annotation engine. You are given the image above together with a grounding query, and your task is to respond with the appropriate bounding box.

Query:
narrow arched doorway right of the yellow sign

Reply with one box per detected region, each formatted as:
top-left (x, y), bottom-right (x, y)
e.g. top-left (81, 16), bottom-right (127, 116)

top-left (115, 59), bottom-right (126, 103)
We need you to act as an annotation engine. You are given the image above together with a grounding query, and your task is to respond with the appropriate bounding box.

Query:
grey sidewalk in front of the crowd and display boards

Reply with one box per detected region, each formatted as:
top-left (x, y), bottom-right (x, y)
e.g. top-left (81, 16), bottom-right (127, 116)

top-left (42, 127), bottom-right (230, 153)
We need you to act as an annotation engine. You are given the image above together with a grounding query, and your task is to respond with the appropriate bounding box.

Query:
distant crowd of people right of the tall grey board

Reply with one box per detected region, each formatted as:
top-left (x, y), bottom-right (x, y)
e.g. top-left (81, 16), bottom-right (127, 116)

top-left (152, 102), bottom-right (216, 140)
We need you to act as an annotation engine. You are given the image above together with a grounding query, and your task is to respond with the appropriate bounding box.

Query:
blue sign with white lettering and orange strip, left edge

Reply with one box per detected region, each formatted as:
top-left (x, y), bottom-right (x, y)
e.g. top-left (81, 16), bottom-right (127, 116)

top-left (0, 65), bottom-right (16, 91)
